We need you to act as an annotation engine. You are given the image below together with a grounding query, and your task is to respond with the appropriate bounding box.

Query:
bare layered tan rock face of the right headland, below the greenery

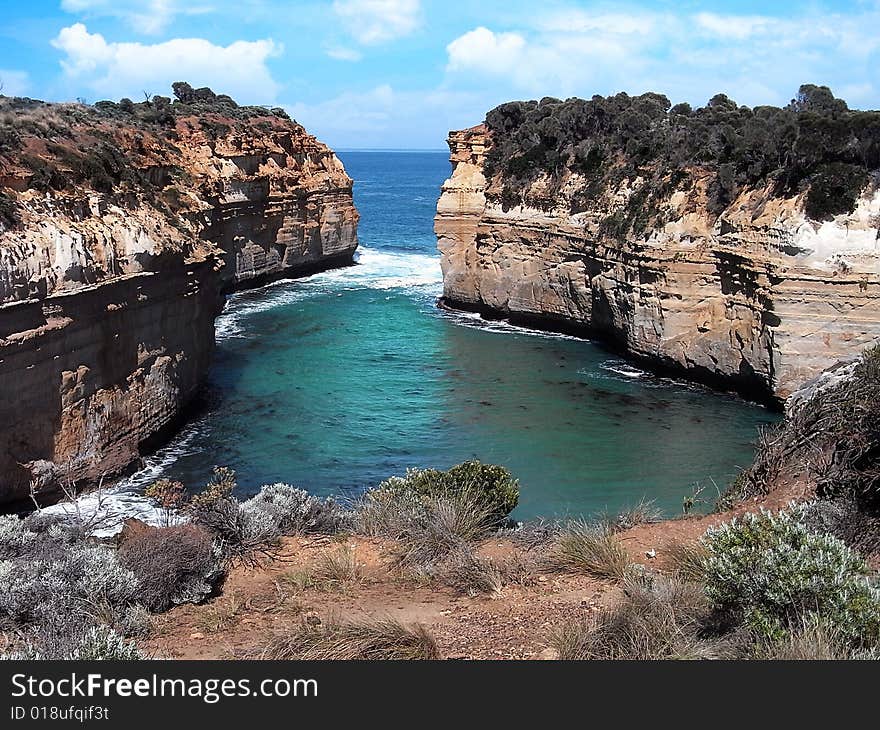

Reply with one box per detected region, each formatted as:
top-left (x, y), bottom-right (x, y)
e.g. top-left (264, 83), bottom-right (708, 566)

top-left (435, 125), bottom-right (880, 400)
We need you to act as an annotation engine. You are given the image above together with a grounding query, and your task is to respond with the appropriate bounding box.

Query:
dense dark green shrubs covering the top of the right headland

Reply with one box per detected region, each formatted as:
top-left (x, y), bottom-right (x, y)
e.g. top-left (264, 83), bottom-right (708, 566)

top-left (485, 85), bottom-right (880, 223)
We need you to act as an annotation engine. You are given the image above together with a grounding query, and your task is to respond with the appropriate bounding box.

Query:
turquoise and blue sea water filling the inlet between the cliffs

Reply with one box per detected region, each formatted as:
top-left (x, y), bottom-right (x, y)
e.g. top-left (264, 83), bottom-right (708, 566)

top-left (125, 152), bottom-right (775, 518)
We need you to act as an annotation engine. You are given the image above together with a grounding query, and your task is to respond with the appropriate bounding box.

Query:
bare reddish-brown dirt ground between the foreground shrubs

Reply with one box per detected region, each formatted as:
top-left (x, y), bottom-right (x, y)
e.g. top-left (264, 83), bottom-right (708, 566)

top-left (144, 483), bottom-right (807, 659)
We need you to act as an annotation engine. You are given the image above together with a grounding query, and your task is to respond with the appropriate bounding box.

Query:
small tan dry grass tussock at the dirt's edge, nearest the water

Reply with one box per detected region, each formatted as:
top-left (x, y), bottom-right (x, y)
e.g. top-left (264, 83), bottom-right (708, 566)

top-left (548, 521), bottom-right (630, 580)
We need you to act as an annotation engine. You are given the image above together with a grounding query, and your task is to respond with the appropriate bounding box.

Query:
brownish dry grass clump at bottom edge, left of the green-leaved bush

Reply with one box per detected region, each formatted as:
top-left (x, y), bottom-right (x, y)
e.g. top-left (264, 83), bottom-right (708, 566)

top-left (549, 575), bottom-right (732, 660)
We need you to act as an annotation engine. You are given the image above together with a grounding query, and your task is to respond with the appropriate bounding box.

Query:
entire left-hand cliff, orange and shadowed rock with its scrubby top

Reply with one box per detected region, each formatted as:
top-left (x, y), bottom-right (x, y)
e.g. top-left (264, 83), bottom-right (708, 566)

top-left (0, 87), bottom-right (358, 503)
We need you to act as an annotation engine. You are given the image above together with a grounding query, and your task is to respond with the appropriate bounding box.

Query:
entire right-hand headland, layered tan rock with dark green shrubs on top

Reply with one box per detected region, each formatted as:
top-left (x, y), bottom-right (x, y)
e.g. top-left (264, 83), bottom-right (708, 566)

top-left (435, 86), bottom-right (880, 403)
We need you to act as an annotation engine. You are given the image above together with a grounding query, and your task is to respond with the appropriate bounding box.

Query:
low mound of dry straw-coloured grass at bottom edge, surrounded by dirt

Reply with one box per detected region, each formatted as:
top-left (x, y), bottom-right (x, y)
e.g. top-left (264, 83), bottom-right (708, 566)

top-left (260, 618), bottom-right (440, 660)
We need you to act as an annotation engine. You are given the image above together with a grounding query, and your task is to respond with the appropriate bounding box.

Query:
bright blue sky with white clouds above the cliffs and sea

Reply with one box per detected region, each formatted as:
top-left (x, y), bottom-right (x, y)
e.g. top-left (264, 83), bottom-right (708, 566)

top-left (0, 0), bottom-right (880, 149)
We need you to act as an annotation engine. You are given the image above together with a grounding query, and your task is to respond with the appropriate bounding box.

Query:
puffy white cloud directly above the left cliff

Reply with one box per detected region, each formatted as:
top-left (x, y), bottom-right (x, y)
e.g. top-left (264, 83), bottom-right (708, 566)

top-left (52, 23), bottom-right (282, 104)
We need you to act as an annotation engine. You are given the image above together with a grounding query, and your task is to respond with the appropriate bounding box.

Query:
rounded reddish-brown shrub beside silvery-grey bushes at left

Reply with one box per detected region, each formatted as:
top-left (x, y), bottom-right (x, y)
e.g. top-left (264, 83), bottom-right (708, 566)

top-left (118, 524), bottom-right (224, 613)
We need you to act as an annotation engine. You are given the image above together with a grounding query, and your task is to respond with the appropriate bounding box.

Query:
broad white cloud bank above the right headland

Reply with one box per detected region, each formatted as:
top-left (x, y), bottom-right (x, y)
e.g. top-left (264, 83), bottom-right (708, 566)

top-left (444, 9), bottom-right (880, 105)
